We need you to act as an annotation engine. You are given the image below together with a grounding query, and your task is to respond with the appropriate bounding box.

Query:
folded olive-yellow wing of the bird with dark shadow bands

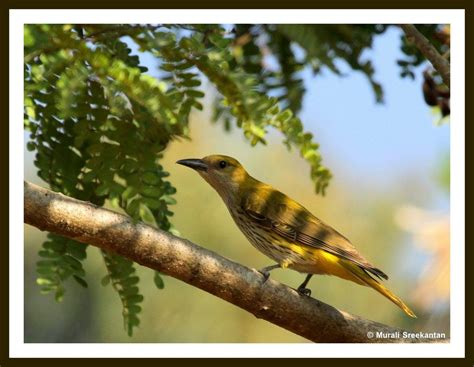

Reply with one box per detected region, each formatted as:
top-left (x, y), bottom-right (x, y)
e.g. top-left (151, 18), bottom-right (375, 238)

top-left (241, 186), bottom-right (388, 279)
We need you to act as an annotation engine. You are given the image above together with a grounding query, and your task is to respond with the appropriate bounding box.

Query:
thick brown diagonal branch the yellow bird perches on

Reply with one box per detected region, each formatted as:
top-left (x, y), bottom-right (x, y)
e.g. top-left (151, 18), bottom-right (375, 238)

top-left (24, 182), bottom-right (446, 343)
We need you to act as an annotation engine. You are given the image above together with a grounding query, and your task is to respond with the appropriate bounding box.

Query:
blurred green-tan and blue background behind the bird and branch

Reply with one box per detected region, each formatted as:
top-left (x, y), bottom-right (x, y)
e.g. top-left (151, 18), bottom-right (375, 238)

top-left (24, 28), bottom-right (450, 343)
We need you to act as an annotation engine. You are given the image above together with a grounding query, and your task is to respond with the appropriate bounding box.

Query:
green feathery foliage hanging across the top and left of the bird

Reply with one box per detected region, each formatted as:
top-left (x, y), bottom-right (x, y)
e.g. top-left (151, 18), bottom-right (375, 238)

top-left (24, 25), bottom-right (444, 335)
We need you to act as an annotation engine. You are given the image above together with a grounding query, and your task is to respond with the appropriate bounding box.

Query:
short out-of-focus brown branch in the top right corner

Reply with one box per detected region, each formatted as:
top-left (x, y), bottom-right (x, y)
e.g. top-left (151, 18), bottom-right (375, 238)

top-left (400, 24), bottom-right (451, 88)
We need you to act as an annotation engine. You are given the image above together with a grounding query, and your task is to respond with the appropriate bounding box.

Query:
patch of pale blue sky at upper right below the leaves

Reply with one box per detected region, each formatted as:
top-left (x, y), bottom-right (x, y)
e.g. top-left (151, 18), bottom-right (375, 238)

top-left (301, 28), bottom-right (450, 185)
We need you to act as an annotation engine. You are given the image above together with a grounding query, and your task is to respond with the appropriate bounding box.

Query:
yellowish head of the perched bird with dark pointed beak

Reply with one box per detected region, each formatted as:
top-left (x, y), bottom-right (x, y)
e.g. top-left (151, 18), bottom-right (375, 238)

top-left (176, 155), bottom-right (249, 201)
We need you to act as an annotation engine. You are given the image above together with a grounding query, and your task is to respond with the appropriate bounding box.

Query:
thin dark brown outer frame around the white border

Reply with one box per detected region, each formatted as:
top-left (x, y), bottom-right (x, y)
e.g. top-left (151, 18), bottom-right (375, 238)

top-left (0, 0), bottom-right (474, 366)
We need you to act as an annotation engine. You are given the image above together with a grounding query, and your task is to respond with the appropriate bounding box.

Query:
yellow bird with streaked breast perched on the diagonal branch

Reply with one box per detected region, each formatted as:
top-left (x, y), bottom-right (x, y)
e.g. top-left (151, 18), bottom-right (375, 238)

top-left (176, 155), bottom-right (416, 318)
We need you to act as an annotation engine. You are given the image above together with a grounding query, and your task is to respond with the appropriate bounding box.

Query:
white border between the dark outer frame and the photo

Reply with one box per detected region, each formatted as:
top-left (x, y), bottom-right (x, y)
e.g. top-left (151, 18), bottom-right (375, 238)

top-left (9, 9), bottom-right (465, 358)
